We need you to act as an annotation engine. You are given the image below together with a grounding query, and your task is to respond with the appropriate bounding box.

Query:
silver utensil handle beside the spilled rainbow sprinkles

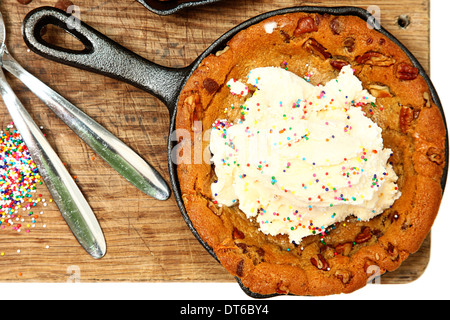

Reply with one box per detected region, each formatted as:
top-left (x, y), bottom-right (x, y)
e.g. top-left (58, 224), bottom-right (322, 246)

top-left (0, 68), bottom-right (106, 259)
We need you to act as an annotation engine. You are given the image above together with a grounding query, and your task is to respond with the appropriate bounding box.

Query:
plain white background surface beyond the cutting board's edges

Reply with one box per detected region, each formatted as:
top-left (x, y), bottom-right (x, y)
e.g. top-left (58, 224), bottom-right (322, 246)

top-left (0, 0), bottom-right (450, 300)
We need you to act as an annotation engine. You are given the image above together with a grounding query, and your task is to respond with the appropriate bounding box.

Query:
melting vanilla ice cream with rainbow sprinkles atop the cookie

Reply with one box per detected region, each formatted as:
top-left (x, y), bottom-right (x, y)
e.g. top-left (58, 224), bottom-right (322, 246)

top-left (210, 66), bottom-right (401, 243)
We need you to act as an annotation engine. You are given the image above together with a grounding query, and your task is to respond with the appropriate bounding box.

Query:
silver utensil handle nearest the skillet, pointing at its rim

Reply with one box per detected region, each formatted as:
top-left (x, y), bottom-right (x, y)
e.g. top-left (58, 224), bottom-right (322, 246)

top-left (3, 51), bottom-right (170, 200)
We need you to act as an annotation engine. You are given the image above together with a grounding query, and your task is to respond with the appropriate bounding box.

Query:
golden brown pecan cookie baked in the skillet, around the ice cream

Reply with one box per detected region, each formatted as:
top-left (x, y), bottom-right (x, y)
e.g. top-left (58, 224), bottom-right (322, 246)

top-left (176, 13), bottom-right (446, 296)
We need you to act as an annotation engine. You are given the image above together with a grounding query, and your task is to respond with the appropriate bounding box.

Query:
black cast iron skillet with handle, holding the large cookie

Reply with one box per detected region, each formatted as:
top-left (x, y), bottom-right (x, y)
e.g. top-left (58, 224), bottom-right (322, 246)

top-left (22, 6), bottom-right (448, 298)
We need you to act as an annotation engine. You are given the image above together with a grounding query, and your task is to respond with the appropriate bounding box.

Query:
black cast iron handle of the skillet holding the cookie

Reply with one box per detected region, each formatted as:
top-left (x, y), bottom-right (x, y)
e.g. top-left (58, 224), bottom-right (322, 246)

top-left (22, 7), bottom-right (189, 112)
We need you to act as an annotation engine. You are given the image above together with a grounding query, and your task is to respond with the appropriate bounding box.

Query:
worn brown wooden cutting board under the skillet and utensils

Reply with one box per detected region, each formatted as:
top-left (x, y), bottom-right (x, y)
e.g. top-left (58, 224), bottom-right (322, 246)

top-left (0, 0), bottom-right (430, 283)
